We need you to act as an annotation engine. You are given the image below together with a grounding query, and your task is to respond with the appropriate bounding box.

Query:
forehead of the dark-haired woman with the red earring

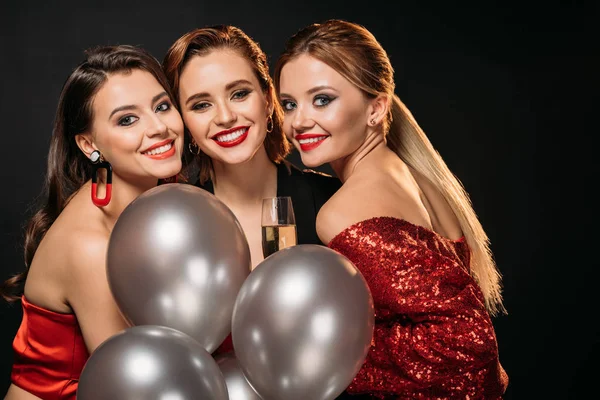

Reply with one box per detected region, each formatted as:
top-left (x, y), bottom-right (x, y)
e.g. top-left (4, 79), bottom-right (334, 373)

top-left (92, 69), bottom-right (164, 115)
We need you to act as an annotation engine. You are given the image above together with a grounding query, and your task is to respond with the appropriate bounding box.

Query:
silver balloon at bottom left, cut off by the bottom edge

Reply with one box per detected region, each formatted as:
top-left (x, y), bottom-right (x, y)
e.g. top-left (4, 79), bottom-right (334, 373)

top-left (77, 325), bottom-right (228, 400)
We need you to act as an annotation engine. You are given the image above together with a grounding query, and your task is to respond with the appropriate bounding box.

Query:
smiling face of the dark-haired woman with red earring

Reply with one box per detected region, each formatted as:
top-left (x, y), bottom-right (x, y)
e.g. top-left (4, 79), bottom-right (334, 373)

top-left (84, 70), bottom-right (183, 179)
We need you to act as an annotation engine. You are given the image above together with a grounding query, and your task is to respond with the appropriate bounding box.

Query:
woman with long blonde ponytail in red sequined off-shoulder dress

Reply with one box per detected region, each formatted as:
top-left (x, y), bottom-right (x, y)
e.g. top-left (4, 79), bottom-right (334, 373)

top-left (275, 20), bottom-right (508, 400)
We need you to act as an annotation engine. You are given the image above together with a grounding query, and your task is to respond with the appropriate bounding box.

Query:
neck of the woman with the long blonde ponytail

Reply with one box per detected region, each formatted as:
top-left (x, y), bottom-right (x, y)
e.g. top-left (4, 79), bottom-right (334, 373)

top-left (330, 130), bottom-right (391, 182)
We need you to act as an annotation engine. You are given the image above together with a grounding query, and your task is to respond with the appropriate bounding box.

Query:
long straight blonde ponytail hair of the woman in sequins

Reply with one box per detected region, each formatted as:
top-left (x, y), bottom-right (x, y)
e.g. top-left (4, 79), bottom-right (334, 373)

top-left (274, 20), bottom-right (505, 314)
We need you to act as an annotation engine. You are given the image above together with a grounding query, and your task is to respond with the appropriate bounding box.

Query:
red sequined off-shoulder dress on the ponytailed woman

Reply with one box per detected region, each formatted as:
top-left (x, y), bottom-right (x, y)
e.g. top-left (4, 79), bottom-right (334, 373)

top-left (329, 217), bottom-right (508, 400)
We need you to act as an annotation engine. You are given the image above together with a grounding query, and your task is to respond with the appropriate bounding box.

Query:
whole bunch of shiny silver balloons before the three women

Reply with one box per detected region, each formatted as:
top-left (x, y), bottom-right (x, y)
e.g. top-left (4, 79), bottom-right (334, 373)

top-left (77, 183), bottom-right (374, 400)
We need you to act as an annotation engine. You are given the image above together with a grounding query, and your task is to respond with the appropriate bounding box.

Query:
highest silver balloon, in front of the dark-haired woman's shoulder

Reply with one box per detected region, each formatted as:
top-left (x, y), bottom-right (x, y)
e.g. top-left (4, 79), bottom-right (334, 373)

top-left (106, 183), bottom-right (251, 353)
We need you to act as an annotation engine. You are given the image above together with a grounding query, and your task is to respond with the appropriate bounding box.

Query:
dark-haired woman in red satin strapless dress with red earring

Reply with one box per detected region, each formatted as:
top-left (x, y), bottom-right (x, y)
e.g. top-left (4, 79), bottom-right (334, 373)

top-left (0, 46), bottom-right (183, 400)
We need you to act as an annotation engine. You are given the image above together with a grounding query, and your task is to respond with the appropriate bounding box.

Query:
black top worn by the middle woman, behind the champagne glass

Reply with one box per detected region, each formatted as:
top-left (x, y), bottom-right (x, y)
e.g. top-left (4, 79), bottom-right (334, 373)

top-left (194, 161), bottom-right (342, 245)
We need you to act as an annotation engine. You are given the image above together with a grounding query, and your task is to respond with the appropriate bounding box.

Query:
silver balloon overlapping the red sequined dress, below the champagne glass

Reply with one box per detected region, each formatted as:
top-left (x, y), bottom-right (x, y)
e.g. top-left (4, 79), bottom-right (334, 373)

top-left (232, 244), bottom-right (374, 400)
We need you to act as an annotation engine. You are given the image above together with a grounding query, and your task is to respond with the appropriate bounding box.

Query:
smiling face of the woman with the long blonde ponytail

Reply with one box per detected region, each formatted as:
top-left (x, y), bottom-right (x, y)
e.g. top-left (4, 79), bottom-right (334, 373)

top-left (279, 54), bottom-right (369, 167)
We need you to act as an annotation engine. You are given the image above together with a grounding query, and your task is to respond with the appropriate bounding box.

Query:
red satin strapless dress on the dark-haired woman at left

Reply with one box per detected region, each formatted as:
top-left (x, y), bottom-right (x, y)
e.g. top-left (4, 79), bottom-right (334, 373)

top-left (11, 296), bottom-right (89, 400)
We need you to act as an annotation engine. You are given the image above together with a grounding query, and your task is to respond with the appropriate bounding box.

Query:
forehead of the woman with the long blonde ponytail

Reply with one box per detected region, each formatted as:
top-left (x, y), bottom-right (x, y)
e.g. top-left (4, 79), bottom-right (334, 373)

top-left (280, 54), bottom-right (354, 93)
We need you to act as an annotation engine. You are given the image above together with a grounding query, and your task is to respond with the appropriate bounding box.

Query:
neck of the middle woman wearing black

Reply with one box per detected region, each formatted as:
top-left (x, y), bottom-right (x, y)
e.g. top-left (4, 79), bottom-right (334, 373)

top-left (213, 146), bottom-right (277, 206)
